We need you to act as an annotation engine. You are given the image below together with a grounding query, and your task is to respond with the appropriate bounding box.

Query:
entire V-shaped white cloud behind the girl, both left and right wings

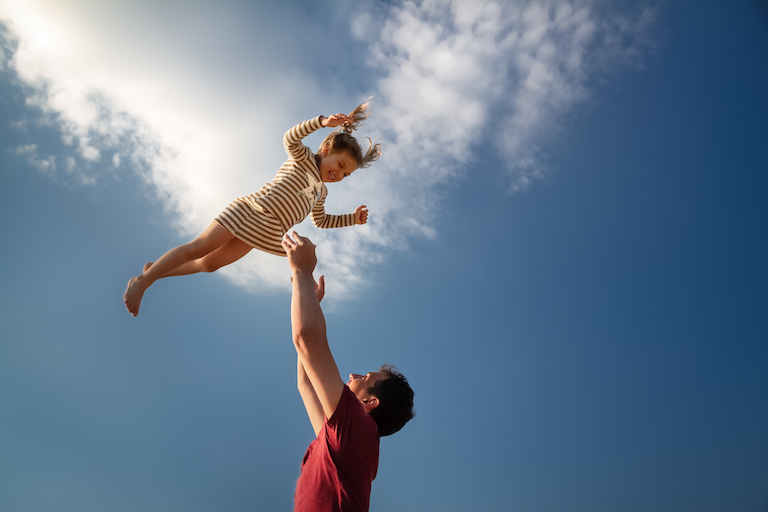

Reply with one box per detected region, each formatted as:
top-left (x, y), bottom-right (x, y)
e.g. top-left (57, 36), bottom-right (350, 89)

top-left (0, 0), bottom-right (653, 297)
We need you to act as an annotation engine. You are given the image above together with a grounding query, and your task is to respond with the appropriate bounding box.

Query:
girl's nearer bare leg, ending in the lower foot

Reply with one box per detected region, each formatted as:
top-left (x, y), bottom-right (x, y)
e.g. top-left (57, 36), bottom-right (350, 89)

top-left (123, 221), bottom-right (235, 316)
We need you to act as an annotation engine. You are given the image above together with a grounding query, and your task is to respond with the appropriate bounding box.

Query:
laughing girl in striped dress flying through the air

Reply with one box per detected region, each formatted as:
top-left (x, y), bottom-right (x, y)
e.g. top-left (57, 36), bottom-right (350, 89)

top-left (123, 102), bottom-right (381, 316)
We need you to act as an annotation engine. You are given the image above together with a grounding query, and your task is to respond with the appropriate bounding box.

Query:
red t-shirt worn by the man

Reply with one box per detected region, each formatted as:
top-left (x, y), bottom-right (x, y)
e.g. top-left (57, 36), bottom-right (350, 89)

top-left (293, 385), bottom-right (379, 512)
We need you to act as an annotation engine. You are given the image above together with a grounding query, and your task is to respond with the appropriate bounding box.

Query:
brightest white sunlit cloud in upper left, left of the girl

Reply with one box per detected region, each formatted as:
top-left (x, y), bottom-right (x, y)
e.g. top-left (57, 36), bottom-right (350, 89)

top-left (0, 0), bottom-right (328, 285)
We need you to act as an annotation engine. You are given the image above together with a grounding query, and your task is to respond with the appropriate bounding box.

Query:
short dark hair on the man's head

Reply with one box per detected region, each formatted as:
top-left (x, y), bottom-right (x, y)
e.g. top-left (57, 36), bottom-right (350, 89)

top-left (368, 364), bottom-right (415, 437)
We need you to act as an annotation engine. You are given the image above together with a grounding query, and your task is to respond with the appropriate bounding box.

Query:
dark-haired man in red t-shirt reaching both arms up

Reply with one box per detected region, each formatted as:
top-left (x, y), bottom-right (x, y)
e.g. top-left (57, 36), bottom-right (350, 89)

top-left (282, 231), bottom-right (413, 512)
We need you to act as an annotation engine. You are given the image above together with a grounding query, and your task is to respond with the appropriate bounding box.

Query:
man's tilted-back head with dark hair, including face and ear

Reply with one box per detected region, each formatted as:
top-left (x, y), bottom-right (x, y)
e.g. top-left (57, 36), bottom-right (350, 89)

top-left (347, 364), bottom-right (415, 437)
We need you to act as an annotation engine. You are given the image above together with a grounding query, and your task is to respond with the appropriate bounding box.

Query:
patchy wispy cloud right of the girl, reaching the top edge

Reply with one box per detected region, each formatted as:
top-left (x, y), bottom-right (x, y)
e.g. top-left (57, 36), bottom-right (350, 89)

top-left (306, 0), bottom-right (653, 294)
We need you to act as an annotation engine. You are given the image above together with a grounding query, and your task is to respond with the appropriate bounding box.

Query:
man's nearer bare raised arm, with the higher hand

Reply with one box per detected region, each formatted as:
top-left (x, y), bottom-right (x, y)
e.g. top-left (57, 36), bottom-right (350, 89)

top-left (282, 231), bottom-right (344, 420)
